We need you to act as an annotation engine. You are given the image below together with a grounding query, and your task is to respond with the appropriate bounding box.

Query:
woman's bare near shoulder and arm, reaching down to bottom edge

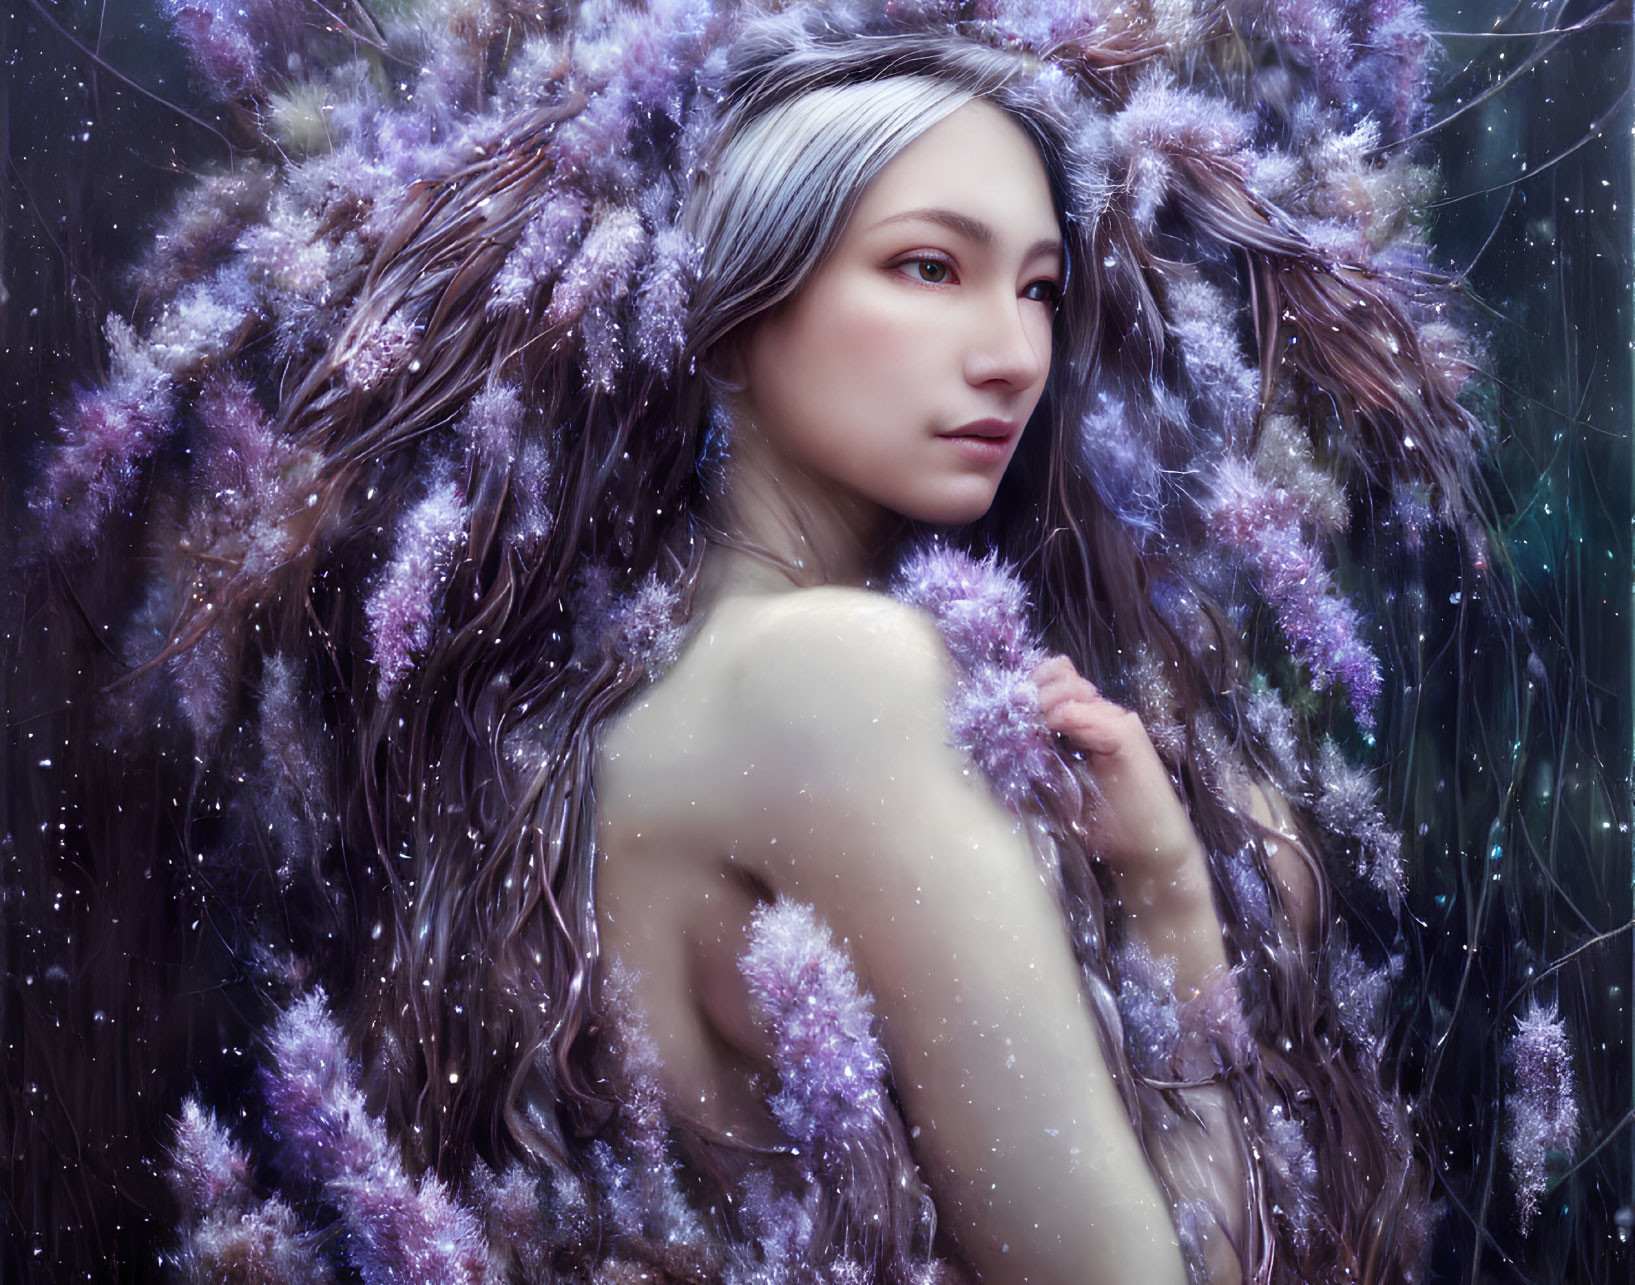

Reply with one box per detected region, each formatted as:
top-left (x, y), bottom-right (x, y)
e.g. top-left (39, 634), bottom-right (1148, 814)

top-left (731, 590), bottom-right (1184, 1285)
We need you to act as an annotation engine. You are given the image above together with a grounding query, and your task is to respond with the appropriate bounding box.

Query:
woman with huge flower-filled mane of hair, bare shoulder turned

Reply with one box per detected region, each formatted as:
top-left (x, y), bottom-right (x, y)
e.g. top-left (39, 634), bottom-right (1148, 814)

top-left (22, 8), bottom-right (1470, 1280)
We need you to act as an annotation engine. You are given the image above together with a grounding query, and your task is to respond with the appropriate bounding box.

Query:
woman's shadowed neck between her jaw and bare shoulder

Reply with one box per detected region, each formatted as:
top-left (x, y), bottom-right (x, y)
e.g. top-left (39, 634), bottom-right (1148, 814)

top-left (700, 415), bottom-right (901, 603)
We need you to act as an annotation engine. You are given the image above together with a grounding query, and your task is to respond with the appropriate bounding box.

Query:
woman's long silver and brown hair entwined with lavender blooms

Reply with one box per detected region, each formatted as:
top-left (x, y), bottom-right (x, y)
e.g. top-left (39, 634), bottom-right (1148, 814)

top-left (22, 11), bottom-right (1472, 1280)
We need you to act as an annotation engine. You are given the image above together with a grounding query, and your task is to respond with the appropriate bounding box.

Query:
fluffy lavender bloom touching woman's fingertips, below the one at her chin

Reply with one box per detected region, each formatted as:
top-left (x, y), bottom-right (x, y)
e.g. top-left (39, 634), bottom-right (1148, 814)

top-left (948, 665), bottom-right (1061, 809)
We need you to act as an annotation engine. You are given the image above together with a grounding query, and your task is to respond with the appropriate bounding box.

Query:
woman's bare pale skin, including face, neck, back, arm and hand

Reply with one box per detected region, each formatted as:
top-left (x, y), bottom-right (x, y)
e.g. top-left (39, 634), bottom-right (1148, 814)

top-left (597, 101), bottom-right (1310, 1285)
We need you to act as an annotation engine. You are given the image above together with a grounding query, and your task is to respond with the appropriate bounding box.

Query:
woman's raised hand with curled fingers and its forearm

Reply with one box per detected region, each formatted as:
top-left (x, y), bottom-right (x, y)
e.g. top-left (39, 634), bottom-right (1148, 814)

top-left (1033, 656), bottom-right (1226, 996)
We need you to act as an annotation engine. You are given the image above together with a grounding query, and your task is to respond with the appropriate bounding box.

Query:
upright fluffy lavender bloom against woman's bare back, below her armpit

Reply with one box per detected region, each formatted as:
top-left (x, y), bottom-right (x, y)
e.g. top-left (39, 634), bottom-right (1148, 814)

top-left (737, 898), bottom-right (886, 1146)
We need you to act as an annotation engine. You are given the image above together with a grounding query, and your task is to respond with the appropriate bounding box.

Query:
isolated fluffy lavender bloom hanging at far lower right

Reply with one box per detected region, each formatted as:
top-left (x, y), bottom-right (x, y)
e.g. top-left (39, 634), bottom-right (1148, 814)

top-left (1504, 999), bottom-right (1578, 1231)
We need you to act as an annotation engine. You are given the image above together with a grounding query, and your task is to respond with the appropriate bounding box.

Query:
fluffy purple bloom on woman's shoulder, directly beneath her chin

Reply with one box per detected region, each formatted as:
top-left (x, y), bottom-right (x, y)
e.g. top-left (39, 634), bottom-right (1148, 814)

top-left (893, 544), bottom-right (1045, 672)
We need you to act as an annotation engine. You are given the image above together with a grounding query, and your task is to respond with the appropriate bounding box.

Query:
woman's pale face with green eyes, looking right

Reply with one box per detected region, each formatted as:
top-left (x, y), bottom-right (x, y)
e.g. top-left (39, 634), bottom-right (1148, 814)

top-left (737, 100), bottom-right (1063, 523)
